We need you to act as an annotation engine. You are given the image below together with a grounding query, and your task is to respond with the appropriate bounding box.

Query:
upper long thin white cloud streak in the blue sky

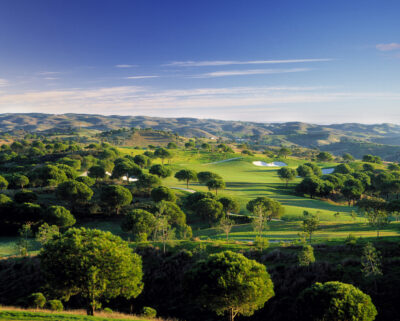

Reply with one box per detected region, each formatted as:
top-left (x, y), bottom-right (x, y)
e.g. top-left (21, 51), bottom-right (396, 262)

top-left (164, 58), bottom-right (333, 67)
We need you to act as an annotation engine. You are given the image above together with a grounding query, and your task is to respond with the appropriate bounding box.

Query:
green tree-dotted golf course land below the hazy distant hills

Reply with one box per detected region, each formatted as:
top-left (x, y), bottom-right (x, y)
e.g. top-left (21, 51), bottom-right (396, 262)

top-left (0, 125), bottom-right (400, 320)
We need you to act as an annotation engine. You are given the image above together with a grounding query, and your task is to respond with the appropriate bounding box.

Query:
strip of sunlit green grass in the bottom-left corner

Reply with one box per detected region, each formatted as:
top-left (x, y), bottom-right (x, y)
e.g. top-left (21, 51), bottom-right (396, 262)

top-left (0, 310), bottom-right (155, 321)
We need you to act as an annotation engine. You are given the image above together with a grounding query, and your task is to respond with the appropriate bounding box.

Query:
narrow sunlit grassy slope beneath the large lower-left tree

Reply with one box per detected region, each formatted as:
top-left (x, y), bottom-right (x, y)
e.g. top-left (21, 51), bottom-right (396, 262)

top-left (0, 307), bottom-right (162, 321)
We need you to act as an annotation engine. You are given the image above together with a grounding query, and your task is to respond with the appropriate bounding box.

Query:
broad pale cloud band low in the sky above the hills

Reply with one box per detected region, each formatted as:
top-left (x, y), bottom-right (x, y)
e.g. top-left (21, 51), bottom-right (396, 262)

top-left (0, 86), bottom-right (400, 120)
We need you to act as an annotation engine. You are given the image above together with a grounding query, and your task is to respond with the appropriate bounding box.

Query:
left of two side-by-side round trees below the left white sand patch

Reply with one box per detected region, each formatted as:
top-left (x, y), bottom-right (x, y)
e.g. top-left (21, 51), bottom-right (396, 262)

top-left (56, 180), bottom-right (93, 206)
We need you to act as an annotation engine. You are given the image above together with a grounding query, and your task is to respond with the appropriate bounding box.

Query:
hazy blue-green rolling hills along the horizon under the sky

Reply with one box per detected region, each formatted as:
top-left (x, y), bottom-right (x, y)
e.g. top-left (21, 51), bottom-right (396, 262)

top-left (0, 113), bottom-right (400, 161)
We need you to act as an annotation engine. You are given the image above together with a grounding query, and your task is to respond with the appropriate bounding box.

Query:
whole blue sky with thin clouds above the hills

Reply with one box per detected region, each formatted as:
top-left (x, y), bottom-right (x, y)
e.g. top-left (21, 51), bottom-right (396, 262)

top-left (0, 0), bottom-right (400, 124)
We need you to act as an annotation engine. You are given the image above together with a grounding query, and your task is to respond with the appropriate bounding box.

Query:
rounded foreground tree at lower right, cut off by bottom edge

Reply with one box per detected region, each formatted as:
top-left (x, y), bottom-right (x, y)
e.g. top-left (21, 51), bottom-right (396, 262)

top-left (296, 281), bottom-right (377, 321)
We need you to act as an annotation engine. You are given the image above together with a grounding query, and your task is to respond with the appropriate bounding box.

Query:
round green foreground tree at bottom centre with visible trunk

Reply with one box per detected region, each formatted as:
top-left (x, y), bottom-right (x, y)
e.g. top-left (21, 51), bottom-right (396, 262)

top-left (185, 251), bottom-right (275, 321)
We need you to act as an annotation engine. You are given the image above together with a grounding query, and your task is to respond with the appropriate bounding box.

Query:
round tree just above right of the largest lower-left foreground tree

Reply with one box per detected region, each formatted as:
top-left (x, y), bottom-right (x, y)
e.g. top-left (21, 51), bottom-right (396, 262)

top-left (121, 209), bottom-right (156, 241)
